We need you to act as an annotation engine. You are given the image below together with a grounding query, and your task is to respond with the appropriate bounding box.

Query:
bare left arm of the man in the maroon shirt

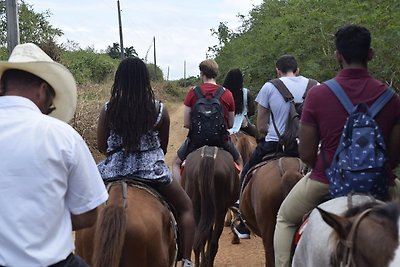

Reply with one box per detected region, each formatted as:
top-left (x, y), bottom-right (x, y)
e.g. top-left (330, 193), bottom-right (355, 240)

top-left (299, 123), bottom-right (319, 168)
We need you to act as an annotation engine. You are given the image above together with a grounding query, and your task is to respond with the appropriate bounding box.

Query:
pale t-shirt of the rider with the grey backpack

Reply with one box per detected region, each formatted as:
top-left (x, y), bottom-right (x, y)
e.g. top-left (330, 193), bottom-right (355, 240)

top-left (256, 76), bottom-right (308, 142)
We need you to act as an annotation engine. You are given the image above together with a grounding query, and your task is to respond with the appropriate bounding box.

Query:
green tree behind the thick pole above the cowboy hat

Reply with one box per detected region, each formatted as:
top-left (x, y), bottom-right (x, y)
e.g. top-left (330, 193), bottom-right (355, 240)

top-left (0, 0), bottom-right (63, 46)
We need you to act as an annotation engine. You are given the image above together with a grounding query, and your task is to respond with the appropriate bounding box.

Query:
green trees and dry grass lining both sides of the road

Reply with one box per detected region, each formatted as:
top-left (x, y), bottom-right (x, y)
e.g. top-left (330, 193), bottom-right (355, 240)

top-left (0, 0), bottom-right (400, 176)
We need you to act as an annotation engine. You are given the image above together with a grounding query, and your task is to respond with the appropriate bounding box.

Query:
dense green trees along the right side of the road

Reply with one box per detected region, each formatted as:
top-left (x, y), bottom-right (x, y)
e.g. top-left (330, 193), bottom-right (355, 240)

top-left (210, 0), bottom-right (400, 92)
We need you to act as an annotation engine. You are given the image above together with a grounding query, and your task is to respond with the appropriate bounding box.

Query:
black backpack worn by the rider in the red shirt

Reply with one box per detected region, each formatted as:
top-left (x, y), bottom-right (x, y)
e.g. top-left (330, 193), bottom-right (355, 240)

top-left (189, 86), bottom-right (228, 149)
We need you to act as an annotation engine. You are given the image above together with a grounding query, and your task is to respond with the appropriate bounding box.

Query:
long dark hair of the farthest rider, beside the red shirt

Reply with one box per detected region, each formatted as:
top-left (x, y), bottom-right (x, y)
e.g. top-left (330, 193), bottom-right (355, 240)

top-left (223, 69), bottom-right (243, 114)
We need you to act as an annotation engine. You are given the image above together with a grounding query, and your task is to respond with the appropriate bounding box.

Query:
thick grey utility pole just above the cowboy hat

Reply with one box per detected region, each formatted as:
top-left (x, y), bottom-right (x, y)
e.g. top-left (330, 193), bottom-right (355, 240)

top-left (6, 0), bottom-right (19, 55)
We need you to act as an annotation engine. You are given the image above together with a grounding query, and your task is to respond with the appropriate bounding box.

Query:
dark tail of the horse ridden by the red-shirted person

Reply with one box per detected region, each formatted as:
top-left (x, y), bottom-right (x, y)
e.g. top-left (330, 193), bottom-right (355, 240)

top-left (193, 157), bottom-right (216, 258)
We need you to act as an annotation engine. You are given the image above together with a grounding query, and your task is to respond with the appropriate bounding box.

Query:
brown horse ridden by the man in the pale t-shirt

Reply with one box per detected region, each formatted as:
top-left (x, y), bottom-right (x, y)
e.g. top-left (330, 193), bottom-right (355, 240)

top-left (239, 157), bottom-right (305, 266)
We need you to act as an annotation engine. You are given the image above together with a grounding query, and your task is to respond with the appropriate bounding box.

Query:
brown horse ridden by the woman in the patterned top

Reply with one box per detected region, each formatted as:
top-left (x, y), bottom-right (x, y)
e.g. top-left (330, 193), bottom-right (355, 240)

top-left (75, 181), bottom-right (177, 267)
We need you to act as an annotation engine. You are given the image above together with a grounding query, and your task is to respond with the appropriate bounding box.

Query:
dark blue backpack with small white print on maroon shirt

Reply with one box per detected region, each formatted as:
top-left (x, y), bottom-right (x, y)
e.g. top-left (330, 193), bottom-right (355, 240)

top-left (325, 79), bottom-right (394, 200)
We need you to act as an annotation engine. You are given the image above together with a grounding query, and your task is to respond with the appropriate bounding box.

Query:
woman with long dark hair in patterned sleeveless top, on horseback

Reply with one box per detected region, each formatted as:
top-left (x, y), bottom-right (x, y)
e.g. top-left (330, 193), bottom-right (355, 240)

top-left (97, 57), bottom-right (195, 266)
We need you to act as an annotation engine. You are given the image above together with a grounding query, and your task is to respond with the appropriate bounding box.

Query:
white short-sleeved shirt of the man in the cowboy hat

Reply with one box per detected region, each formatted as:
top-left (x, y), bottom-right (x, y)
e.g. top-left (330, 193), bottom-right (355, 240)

top-left (0, 96), bottom-right (108, 267)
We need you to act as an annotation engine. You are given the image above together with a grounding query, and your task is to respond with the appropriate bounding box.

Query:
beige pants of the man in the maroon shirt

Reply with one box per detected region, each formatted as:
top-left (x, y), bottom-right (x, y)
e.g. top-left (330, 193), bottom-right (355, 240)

top-left (274, 173), bottom-right (400, 267)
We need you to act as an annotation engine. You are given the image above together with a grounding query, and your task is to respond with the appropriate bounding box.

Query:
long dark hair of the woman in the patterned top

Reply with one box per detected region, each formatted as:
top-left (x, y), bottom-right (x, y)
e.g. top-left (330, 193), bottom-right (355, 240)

top-left (106, 57), bottom-right (157, 152)
